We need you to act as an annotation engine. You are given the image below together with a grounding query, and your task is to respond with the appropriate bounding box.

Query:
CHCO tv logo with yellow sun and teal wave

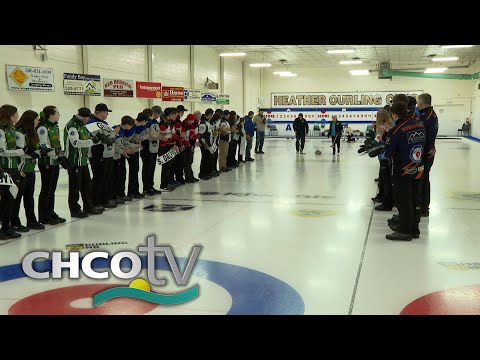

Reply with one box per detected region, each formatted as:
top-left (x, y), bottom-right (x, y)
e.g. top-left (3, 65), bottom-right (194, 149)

top-left (22, 236), bottom-right (202, 306)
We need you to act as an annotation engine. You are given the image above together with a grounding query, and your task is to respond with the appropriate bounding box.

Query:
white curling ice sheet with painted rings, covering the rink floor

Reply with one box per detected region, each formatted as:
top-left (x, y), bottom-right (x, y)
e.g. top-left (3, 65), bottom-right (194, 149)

top-left (0, 138), bottom-right (480, 315)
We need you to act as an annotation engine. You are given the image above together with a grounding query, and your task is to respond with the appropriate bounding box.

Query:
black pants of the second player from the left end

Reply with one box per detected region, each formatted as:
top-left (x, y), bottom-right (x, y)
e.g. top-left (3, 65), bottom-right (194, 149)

top-left (10, 172), bottom-right (37, 226)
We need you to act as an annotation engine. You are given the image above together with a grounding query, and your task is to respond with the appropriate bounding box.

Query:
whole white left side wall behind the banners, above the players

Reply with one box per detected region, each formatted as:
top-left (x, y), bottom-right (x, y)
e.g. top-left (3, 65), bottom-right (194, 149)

top-left (0, 45), bottom-right (251, 124)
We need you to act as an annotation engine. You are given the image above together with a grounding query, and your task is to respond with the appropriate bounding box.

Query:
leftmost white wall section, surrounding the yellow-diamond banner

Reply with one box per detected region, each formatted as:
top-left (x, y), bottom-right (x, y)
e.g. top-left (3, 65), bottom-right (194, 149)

top-left (0, 45), bottom-right (84, 123)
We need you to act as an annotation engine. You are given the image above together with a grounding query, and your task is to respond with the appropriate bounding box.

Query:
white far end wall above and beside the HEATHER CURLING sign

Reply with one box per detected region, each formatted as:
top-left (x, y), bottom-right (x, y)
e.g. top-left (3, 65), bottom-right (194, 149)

top-left (262, 68), bottom-right (472, 135)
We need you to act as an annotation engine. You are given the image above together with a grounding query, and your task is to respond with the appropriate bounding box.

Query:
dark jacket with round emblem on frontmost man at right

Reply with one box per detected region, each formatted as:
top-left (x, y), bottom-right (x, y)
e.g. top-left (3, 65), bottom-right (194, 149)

top-left (385, 116), bottom-right (425, 179)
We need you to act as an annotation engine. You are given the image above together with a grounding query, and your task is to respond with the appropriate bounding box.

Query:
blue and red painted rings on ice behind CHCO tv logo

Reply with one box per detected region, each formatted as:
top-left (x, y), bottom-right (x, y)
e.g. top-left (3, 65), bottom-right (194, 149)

top-left (0, 256), bottom-right (305, 315)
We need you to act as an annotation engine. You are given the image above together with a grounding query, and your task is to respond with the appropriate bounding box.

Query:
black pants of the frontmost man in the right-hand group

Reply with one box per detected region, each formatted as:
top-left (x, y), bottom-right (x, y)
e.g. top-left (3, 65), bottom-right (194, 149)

top-left (395, 178), bottom-right (422, 234)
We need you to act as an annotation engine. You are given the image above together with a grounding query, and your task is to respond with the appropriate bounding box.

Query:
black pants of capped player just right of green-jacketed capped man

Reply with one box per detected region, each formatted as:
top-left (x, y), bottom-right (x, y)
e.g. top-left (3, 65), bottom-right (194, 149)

top-left (90, 157), bottom-right (113, 206)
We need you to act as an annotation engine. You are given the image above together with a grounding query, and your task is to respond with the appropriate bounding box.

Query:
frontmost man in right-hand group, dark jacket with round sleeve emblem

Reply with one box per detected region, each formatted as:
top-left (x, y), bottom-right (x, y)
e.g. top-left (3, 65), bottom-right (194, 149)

top-left (385, 102), bottom-right (425, 241)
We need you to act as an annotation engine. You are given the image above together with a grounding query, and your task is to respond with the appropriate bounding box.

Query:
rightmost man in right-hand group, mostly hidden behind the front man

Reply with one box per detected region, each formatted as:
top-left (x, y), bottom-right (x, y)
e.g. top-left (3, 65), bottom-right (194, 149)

top-left (417, 93), bottom-right (438, 216)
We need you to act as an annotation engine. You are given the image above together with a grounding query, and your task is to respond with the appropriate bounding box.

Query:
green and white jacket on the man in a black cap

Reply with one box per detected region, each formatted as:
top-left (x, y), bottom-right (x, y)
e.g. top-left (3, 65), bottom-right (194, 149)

top-left (63, 115), bottom-right (93, 166)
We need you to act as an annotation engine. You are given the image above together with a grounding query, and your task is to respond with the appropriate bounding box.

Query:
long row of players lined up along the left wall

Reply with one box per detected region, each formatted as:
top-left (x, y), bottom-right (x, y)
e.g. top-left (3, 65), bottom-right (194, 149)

top-left (0, 104), bottom-right (265, 240)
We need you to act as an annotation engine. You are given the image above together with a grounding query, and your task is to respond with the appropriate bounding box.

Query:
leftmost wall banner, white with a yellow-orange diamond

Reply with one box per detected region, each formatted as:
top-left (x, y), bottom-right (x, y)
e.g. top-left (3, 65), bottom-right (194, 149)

top-left (5, 65), bottom-right (55, 92)
